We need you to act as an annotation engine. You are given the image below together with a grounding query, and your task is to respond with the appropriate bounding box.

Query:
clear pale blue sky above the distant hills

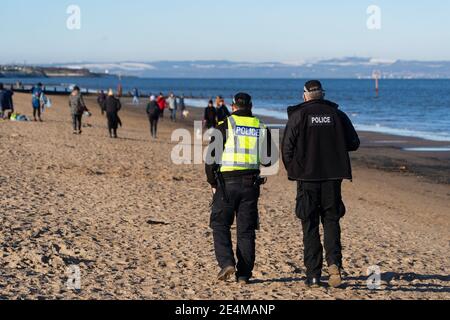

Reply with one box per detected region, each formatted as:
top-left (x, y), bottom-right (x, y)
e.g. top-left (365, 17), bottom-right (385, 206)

top-left (0, 0), bottom-right (450, 63)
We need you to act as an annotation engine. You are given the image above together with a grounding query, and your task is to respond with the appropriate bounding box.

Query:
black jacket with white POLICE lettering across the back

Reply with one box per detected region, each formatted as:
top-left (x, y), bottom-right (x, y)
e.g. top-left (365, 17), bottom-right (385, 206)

top-left (282, 100), bottom-right (360, 181)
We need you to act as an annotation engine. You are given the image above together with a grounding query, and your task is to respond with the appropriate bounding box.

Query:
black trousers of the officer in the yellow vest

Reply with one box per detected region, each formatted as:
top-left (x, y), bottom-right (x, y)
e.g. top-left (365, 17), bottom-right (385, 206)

top-left (211, 176), bottom-right (260, 278)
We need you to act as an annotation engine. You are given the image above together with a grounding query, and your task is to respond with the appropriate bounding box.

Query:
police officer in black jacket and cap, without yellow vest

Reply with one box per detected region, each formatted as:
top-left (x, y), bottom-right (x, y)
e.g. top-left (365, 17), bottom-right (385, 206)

top-left (282, 80), bottom-right (360, 288)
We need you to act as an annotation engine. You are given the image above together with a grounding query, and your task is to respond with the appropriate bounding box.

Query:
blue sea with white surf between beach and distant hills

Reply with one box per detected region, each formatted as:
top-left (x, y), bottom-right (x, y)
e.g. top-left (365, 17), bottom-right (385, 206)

top-left (1, 77), bottom-right (450, 141)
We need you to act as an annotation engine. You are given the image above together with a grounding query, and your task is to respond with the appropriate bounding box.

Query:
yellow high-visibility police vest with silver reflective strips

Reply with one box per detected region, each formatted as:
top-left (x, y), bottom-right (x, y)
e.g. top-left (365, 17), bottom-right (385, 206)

top-left (220, 115), bottom-right (267, 172)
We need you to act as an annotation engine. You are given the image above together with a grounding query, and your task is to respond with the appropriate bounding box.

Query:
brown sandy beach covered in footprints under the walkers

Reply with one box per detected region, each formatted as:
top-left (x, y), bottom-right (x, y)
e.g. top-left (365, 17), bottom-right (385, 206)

top-left (0, 94), bottom-right (450, 300)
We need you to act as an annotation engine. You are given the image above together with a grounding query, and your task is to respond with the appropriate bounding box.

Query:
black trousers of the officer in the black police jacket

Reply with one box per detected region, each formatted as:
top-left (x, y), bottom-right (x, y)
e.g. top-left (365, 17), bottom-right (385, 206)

top-left (296, 181), bottom-right (345, 278)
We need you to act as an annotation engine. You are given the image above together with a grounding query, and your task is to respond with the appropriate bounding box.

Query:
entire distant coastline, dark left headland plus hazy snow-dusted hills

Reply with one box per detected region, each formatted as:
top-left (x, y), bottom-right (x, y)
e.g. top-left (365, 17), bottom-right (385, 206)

top-left (0, 57), bottom-right (450, 80)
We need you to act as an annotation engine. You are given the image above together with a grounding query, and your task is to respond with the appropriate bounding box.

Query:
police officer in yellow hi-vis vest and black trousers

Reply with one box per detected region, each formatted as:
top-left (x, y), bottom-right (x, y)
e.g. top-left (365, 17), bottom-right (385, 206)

top-left (206, 93), bottom-right (272, 284)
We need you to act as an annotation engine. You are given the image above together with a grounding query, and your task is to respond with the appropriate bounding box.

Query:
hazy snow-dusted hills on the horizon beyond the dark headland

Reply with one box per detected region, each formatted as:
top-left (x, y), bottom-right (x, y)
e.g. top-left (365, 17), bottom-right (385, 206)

top-left (46, 57), bottom-right (450, 79)
